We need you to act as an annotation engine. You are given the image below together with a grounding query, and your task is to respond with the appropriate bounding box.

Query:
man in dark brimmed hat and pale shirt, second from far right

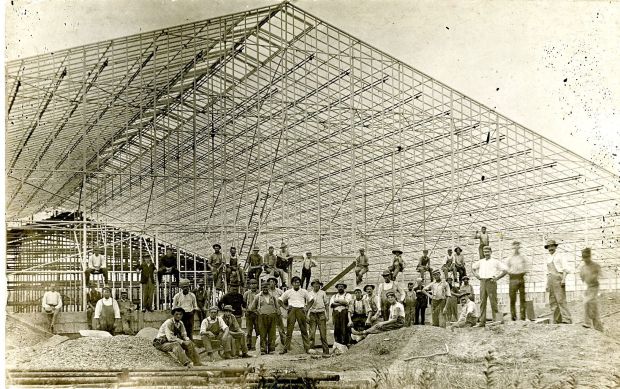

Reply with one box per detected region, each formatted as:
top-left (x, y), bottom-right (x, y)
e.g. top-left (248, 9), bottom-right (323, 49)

top-left (545, 239), bottom-right (572, 324)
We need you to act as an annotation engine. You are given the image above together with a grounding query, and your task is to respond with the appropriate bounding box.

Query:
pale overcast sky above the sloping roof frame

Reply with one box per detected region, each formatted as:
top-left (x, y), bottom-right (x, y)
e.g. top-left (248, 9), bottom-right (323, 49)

top-left (5, 0), bottom-right (620, 174)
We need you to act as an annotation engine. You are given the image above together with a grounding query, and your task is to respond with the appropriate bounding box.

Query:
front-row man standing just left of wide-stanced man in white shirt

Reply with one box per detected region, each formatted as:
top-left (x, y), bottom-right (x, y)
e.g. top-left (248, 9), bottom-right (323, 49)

top-left (249, 283), bottom-right (283, 355)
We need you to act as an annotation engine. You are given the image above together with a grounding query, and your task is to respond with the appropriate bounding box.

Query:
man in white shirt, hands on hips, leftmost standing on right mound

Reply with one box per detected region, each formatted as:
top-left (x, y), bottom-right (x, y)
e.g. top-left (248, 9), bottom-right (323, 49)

top-left (472, 246), bottom-right (508, 327)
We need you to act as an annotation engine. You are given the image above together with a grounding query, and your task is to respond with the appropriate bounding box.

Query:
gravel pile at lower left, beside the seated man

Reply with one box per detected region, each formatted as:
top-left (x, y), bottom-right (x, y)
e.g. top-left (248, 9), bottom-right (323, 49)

top-left (7, 335), bottom-right (179, 369)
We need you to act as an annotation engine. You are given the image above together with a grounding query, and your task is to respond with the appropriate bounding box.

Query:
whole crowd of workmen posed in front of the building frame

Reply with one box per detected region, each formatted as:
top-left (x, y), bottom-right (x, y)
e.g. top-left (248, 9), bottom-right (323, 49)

top-left (43, 227), bottom-right (602, 366)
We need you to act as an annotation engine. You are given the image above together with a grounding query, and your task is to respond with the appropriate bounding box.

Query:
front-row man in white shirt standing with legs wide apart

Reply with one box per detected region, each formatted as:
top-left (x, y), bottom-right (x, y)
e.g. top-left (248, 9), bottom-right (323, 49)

top-left (280, 276), bottom-right (310, 354)
